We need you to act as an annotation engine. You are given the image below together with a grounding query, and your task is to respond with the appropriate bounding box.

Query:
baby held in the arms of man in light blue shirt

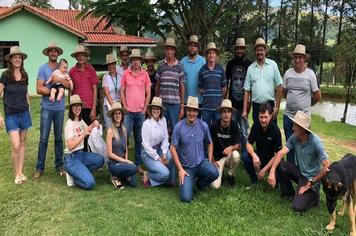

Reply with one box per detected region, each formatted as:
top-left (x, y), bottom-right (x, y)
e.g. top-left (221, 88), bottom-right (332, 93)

top-left (46, 59), bottom-right (73, 102)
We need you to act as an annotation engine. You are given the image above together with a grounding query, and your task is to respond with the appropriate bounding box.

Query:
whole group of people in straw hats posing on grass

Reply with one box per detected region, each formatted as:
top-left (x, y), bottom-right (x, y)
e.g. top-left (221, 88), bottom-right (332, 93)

top-left (0, 35), bottom-right (330, 212)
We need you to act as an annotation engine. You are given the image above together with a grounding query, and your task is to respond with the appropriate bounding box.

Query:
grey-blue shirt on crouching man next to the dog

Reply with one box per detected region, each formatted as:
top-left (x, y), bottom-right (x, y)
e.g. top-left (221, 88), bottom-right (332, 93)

top-left (286, 133), bottom-right (328, 179)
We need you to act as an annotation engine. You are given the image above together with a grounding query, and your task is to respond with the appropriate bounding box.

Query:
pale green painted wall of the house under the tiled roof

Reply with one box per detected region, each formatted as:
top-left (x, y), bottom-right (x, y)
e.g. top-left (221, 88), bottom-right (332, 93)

top-left (0, 10), bottom-right (78, 95)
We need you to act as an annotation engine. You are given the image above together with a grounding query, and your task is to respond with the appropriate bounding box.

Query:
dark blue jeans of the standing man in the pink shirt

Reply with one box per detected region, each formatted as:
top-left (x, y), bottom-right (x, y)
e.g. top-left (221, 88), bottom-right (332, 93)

top-left (124, 112), bottom-right (145, 166)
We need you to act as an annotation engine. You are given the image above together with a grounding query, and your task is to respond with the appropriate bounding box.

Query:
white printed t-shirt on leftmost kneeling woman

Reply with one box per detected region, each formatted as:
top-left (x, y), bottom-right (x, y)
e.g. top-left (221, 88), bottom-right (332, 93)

top-left (64, 119), bottom-right (88, 154)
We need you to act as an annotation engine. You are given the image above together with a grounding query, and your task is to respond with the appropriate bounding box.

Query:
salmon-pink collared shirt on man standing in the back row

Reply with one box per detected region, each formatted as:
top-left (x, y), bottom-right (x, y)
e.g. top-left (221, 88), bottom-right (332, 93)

top-left (121, 68), bottom-right (151, 112)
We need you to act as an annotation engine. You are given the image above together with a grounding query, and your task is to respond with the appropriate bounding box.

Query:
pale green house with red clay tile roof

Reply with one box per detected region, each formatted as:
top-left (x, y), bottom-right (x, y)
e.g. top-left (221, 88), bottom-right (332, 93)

top-left (0, 4), bottom-right (156, 95)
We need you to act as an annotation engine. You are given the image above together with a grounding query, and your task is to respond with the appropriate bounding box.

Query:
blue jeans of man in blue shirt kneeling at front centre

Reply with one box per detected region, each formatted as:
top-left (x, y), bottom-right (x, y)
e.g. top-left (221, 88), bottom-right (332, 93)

top-left (180, 159), bottom-right (219, 202)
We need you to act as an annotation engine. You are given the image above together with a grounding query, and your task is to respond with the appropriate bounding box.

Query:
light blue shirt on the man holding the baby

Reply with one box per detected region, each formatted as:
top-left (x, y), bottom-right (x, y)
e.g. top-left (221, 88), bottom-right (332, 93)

top-left (37, 63), bottom-right (66, 111)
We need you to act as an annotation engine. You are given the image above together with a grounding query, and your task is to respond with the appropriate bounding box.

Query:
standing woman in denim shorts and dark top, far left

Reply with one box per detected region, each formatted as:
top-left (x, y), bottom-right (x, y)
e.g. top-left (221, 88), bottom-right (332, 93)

top-left (0, 46), bottom-right (32, 184)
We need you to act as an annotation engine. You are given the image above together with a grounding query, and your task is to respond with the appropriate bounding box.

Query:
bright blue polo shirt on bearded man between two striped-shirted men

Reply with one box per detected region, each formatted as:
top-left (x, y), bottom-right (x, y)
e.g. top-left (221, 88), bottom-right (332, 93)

top-left (180, 55), bottom-right (206, 104)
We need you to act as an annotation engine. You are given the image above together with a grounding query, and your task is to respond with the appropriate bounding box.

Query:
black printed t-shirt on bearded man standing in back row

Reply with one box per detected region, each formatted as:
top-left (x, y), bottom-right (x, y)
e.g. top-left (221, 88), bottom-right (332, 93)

top-left (226, 56), bottom-right (252, 110)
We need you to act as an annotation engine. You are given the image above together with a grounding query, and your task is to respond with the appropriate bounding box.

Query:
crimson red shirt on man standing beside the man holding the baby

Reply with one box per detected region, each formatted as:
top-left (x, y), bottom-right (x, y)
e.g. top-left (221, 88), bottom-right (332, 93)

top-left (69, 64), bottom-right (99, 109)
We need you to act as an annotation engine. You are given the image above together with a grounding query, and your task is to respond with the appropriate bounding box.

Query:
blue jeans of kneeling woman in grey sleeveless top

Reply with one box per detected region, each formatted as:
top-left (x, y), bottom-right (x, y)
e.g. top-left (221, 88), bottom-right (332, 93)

top-left (108, 160), bottom-right (137, 187)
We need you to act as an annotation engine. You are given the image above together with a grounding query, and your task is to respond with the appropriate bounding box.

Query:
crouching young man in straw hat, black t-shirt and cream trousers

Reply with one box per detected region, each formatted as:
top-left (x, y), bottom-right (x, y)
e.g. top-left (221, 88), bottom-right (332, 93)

top-left (211, 99), bottom-right (240, 189)
